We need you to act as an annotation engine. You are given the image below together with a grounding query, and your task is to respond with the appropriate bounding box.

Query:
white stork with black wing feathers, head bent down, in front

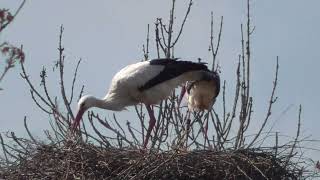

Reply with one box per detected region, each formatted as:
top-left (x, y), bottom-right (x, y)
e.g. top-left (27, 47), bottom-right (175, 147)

top-left (73, 59), bottom-right (212, 148)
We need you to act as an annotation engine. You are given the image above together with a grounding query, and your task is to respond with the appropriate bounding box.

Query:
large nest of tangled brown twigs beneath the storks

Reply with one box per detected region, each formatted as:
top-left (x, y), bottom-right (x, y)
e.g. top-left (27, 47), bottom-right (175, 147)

top-left (0, 142), bottom-right (300, 180)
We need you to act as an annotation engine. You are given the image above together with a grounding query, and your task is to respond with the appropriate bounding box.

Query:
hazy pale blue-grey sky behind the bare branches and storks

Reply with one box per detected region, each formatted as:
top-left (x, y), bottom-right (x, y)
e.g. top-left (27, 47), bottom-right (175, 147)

top-left (0, 0), bottom-right (320, 159)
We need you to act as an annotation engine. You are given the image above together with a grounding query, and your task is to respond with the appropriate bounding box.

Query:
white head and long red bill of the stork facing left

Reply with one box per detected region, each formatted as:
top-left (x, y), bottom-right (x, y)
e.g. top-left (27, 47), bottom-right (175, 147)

top-left (72, 95), bottom-right (97, 130)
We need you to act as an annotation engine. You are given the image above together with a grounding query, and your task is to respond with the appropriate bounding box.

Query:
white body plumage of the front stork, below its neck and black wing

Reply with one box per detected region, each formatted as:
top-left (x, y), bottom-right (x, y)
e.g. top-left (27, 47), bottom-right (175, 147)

top-left (104, 61), bottom-right (203, 107)
